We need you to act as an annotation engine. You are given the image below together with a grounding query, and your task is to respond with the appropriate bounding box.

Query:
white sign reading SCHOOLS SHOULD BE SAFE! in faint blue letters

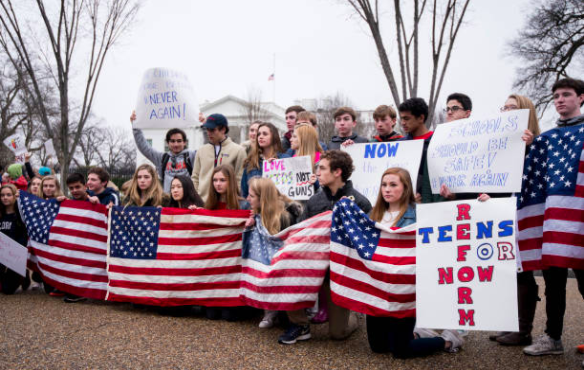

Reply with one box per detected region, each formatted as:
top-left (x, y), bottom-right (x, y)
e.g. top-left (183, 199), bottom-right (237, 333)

top-left (428, 109), bottom-right (529, 194)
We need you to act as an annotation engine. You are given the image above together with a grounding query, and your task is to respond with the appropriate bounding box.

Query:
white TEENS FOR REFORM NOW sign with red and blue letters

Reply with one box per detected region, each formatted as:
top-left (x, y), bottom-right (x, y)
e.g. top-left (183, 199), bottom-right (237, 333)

top-left (416, 198), bottom-right (519, 331)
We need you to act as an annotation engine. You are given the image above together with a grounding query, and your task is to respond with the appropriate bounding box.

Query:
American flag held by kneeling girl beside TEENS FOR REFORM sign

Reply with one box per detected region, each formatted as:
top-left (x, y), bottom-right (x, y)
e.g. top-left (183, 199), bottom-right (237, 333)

top-left (330, 199), bottom-right (416, 318)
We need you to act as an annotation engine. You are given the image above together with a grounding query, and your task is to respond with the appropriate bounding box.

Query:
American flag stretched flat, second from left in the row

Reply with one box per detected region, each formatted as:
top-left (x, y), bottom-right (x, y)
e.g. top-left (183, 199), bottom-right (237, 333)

top-left (106, 207), bottom-right (250, 306)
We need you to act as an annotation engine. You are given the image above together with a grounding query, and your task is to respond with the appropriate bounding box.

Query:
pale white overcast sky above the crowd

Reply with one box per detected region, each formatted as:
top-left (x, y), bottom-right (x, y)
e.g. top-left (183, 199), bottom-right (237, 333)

top-left (93, 0), bottom-right (548, 131)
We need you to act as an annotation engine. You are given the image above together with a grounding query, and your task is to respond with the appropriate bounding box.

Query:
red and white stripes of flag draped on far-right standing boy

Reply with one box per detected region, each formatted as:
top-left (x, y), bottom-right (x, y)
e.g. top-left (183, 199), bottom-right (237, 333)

top-left (517, 143), bottom-right (584, 271)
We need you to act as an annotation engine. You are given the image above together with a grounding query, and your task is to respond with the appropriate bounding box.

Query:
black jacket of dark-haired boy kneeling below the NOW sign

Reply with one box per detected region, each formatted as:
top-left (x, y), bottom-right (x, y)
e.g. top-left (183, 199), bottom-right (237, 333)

top-left (299, 180), bottom-right (372, 221)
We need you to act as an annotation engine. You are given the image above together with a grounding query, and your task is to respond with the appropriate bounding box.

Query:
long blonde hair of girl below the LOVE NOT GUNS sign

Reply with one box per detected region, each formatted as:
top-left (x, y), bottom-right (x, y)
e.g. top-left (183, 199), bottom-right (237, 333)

top-left (249, 177), bottom-right (292, 234)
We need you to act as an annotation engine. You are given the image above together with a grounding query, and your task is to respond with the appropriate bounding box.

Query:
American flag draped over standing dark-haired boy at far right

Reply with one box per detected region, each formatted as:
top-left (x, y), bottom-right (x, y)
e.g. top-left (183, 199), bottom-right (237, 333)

top-left (517, 124), bottom-right (584, 271)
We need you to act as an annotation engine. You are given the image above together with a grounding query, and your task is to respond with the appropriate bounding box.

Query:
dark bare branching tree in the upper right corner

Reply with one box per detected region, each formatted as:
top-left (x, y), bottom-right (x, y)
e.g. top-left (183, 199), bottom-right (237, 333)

top-left (509, 0), bottom-right (584, 114)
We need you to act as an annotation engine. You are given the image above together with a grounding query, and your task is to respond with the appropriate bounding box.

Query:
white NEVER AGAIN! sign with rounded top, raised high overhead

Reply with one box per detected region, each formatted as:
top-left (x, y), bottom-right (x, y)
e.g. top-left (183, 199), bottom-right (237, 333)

top-left (134, 68), bottom-right (199, 129)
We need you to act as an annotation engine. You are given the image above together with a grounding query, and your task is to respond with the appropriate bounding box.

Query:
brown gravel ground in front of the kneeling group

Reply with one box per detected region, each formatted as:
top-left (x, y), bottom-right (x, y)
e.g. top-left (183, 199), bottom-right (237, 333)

top-left (0, 278), bottom-right (584, 370)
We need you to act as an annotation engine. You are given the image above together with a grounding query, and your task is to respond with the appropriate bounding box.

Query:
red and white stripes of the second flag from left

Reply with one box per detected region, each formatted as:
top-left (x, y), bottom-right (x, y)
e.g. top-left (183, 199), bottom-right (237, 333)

top-left (106, 208), bottom-right (249, 306)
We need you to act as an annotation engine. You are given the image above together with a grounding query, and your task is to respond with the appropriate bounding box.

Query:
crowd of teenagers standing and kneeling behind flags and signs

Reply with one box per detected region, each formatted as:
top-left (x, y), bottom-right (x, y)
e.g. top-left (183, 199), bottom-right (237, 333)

top-left (0, 78), bottom-right (584, 357)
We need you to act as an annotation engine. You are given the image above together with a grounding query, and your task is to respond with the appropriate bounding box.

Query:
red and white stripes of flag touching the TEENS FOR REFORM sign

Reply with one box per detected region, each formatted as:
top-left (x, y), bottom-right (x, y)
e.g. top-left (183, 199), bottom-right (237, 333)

top-left (330, 223), bottom-right (416, 318)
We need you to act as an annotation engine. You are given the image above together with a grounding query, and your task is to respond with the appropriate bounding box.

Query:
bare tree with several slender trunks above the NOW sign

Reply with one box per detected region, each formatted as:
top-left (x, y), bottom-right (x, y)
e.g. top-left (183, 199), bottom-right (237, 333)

top-left (346, 0), bottom-right (470, 122)
